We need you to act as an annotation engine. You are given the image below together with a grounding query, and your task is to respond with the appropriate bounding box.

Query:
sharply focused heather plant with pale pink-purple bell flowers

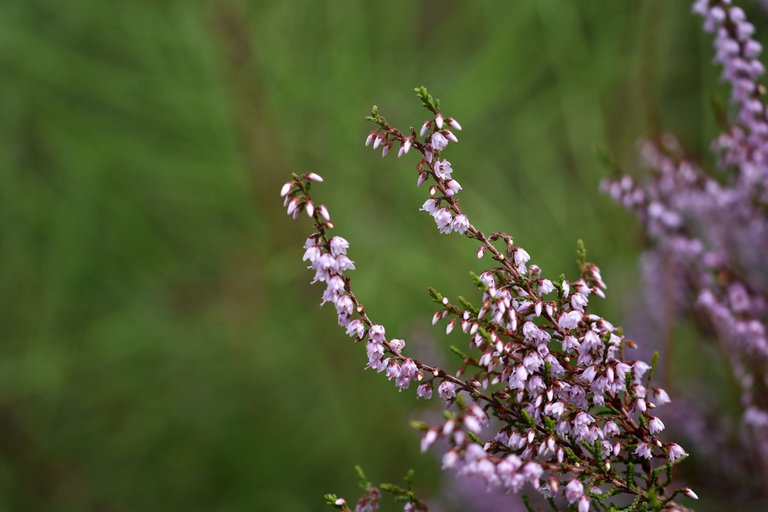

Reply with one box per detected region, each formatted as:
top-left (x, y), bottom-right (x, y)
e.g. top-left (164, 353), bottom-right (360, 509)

top-left (281, 87), bottom-right (696, 512)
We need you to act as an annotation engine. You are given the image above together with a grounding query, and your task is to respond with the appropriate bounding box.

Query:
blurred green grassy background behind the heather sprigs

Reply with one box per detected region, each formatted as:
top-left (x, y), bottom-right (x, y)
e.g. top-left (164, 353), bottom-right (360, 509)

top-left (0, 0), bottom-right (768, 512)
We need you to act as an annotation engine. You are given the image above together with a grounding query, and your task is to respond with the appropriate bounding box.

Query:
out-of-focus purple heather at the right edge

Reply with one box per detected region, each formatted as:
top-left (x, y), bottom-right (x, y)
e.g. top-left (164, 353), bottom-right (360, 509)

top-left (604, 0), bottom-right (768, 480)
